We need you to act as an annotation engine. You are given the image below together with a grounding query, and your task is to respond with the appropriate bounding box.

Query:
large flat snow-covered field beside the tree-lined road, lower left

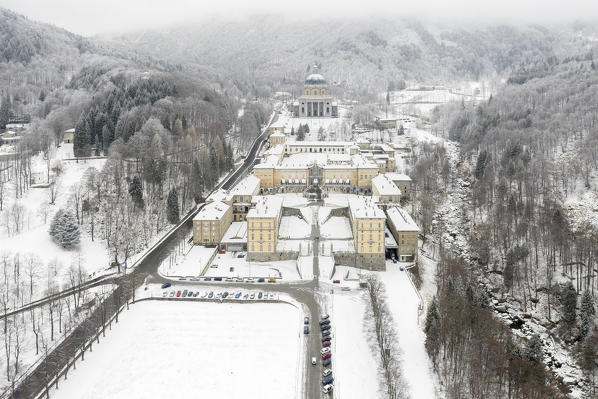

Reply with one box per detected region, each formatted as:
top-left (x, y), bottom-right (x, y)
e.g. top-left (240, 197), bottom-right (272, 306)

top-left (52, 301), bottom-right (303, 399)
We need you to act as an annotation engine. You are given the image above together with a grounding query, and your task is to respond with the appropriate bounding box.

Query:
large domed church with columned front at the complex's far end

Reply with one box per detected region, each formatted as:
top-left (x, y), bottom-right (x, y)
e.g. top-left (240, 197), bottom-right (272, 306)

top-left (293, 66), bottom-right (338, 118)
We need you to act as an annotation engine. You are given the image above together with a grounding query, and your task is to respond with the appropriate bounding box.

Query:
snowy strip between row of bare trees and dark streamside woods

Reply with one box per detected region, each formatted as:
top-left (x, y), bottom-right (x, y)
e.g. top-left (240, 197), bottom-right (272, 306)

top-left (377, 262), bottom-right (436, 399)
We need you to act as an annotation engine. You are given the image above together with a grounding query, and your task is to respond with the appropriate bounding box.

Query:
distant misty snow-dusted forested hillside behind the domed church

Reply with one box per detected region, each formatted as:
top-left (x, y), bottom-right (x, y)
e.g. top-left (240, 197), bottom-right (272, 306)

top-left (105, 16), bottom-right (561, 96)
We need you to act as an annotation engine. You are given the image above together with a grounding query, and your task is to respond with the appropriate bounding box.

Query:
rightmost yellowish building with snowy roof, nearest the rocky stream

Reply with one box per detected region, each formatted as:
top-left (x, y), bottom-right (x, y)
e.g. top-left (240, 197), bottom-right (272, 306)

top-left (386, 206), bottom-right (419, 262)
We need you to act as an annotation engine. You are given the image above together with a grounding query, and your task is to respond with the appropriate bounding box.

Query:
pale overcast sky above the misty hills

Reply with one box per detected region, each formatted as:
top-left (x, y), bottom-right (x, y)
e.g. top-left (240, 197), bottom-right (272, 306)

top-left (0, 0), bottom-right (598, 36)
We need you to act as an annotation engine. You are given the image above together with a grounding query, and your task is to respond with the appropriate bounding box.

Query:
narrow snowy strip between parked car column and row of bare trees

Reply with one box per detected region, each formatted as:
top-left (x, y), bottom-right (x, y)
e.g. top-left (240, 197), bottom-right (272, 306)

top-left (328, 290), bottom-right (382, 399)
